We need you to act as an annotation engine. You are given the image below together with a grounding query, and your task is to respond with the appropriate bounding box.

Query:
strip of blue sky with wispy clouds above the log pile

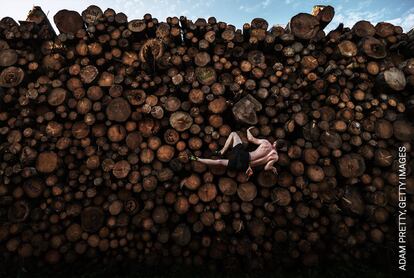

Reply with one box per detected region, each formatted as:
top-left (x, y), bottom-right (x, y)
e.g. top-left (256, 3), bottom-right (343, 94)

top-left (0, 0), bottom-right (414, 32)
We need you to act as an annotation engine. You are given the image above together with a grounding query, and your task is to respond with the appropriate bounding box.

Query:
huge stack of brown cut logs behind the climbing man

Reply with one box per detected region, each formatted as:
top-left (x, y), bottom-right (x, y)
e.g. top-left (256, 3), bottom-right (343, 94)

top-left (0, 6), bottom-right (414, 269)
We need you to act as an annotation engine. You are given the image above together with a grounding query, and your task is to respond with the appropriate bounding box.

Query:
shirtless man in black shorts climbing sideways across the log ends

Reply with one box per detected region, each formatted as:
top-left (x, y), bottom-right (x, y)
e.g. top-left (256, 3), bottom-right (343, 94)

top-left (190, 127), bottom-right (279, 177)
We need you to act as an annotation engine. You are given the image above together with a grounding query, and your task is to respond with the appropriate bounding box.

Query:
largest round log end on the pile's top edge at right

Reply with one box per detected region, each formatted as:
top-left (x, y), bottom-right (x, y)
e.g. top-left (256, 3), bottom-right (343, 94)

top-left (287, 13), bottom-right (320, 40)
